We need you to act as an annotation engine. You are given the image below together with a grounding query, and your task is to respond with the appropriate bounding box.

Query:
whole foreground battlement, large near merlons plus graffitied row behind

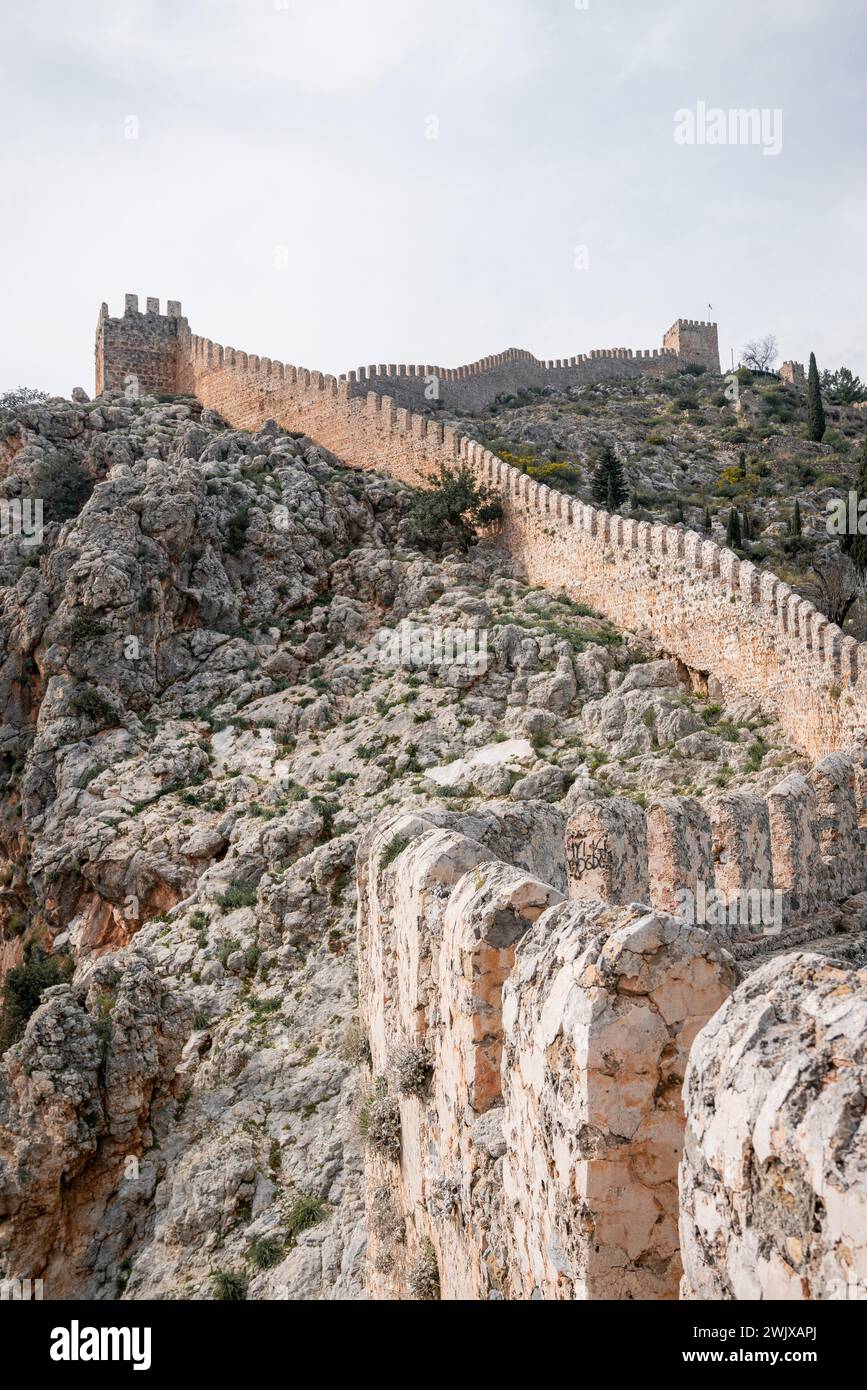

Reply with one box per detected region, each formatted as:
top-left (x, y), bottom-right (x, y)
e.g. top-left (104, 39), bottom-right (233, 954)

top-left (356, 748), bottom-right (867, 1301)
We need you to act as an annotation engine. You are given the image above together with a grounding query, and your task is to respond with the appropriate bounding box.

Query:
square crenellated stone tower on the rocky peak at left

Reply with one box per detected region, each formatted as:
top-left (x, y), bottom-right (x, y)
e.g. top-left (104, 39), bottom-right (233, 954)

top-left (96, 295), bottom-right (189, 396)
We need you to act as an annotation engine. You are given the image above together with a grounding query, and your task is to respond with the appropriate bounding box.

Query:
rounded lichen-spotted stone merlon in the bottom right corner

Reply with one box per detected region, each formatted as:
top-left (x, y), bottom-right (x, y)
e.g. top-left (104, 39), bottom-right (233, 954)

top-left (681, 954), bottom-right (867, 1301)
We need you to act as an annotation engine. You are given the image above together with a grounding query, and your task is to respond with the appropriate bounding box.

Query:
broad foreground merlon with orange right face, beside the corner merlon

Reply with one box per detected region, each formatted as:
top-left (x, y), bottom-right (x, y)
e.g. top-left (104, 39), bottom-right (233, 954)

top-left (503, 902), bottom-right (736, 1300)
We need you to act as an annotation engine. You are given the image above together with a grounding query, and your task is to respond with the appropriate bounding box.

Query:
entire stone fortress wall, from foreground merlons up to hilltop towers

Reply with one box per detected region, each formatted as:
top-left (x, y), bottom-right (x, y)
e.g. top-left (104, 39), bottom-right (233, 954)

top-left (97, 303), bottom-right (867, 1300)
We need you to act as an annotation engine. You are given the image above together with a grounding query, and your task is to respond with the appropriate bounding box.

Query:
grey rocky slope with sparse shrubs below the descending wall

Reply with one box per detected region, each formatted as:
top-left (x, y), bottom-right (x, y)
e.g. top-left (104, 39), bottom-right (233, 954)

top-left (0, 382), bottom-right (799, 1298)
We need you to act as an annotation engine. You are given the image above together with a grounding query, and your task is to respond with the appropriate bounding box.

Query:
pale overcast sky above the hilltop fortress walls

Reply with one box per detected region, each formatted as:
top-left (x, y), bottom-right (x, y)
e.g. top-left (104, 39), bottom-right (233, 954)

top-left (0, 0), bottom-right (867, 395)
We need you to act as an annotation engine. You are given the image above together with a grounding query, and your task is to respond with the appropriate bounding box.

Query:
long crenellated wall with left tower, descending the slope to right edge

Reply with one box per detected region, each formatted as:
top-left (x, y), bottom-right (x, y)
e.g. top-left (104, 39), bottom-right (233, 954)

top-left (96, 295), bottom-right (867, 759)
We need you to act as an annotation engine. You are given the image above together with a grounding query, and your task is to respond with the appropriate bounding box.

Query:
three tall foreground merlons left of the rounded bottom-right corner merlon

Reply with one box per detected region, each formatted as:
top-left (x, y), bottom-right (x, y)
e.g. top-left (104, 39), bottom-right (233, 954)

top-left (358, 806), bottom-right (736, 1301)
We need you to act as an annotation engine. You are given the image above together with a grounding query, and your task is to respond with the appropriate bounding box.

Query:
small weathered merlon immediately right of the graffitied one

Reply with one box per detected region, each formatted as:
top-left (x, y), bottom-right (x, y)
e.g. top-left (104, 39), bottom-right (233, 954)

top-left (647, 796), bottom-right (714, 912)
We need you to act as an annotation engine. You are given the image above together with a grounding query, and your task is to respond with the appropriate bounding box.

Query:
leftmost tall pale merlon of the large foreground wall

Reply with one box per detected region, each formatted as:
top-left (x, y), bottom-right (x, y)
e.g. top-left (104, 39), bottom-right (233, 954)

top-left (357, 813), bottom-right (502, 1298)
